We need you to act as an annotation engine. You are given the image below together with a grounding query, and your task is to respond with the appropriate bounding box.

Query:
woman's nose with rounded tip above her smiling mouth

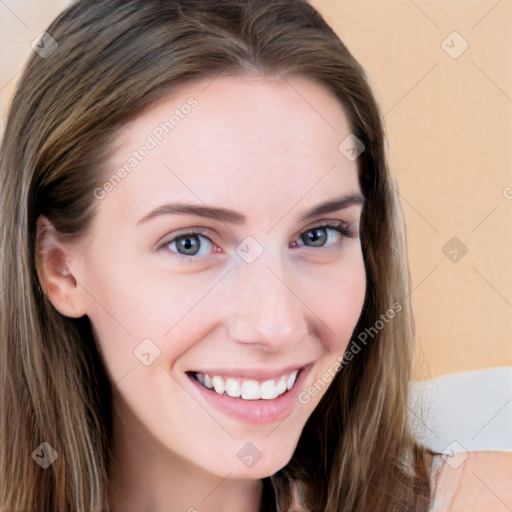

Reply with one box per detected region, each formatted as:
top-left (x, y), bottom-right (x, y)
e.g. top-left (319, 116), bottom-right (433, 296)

top-left (227, 253), bottom-right (309, 351)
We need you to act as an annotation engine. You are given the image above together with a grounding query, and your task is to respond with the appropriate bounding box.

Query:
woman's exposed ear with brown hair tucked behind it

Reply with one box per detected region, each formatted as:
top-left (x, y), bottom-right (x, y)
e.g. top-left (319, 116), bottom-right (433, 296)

top-left (35, 215), bottom-right (85, 318)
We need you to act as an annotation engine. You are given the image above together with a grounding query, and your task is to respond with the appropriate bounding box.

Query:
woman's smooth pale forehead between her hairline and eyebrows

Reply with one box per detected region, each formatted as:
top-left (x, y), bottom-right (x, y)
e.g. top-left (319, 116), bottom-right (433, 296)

top-left (98, 76), bottom-right (360, 221)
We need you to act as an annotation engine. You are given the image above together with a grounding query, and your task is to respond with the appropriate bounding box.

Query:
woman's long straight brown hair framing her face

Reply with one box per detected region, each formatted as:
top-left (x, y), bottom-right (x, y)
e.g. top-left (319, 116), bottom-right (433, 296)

top-left (0, 0), bottom-right (432, 512)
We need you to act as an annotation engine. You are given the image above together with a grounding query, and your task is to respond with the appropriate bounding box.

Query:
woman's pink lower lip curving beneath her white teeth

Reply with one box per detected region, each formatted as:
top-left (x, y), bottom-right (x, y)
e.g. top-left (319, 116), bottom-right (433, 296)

top-left (188, 364), bottom-right (312, 425)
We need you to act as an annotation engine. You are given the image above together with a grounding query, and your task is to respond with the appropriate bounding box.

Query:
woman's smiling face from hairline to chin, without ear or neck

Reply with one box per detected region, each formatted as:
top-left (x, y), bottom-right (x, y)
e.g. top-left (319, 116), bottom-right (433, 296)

top-left (70, 76), bottom-right (366, 478)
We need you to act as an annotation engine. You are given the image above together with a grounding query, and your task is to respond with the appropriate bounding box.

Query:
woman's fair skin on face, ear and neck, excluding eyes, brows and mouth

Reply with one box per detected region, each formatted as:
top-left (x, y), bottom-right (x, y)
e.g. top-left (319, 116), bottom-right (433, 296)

top-left (38, 76), bottom-right (366, 512)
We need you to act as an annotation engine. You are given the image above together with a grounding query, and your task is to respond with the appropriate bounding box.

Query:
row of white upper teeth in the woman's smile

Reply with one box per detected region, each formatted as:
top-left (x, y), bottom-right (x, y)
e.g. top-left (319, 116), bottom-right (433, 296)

top-left (194, 370), bottom-right (299, 400)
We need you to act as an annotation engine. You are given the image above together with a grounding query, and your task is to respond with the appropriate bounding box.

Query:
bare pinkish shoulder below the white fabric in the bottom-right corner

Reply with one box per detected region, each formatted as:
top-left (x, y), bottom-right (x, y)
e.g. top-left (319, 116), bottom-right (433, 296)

top-left (431, 451), bottom-right (512, 512)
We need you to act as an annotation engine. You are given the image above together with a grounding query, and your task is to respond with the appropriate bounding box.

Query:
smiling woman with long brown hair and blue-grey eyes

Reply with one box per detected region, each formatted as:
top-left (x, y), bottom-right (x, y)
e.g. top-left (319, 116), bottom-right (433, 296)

top-left (0, 0), bottom-right (440, 512)
